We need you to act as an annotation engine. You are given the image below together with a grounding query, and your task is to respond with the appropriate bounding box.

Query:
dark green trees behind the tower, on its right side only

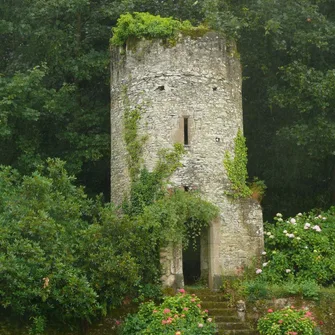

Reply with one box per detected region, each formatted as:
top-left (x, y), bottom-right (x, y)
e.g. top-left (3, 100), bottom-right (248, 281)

top-left (205, 0), bottom-right (335, 217)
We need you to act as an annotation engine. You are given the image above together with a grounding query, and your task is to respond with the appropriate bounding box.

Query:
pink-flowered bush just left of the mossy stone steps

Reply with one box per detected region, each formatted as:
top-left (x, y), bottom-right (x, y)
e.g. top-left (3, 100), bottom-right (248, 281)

top-left (122, 290), bottom-right (216, 335)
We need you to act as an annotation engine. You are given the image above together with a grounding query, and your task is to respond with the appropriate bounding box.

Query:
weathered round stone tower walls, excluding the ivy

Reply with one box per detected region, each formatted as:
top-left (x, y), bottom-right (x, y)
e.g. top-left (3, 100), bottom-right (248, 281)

top-left (111, 32), bottom-right (263, 288)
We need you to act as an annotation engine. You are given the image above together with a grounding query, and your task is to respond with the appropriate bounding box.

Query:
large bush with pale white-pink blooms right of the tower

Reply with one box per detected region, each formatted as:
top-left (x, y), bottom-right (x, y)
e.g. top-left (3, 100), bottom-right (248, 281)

top-left (256, 207), bottom-right (335, 285)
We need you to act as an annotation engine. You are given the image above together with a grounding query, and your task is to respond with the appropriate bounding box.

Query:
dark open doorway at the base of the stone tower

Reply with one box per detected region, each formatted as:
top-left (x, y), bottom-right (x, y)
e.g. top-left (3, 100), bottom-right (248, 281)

top-left (183, 236), bottom-right (201, 285)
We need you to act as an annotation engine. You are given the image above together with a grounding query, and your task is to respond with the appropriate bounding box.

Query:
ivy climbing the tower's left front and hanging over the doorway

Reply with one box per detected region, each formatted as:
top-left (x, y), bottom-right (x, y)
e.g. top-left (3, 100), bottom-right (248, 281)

top-left (122, 80), bottom-right (218, 252)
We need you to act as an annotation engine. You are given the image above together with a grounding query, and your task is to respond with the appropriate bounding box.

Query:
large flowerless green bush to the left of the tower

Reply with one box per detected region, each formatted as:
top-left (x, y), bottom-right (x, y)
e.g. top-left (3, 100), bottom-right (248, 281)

top-left (0, 160), bottom-right (138, 333)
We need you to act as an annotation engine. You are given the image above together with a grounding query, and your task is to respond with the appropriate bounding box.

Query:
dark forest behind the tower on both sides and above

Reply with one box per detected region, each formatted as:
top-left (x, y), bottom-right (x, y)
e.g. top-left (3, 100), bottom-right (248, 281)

top-left (0, 0), bottom-right (335, 219)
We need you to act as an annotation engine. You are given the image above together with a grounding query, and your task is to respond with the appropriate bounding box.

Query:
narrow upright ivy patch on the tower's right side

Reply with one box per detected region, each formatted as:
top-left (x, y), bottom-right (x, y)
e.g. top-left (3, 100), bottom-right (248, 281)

top-left (223, 129), bottom-right (252, 198)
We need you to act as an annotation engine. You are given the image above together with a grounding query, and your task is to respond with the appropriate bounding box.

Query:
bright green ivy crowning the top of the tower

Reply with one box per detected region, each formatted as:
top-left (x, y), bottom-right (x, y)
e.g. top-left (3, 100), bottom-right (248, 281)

top-left (111, 12), bottom-right (209, 46)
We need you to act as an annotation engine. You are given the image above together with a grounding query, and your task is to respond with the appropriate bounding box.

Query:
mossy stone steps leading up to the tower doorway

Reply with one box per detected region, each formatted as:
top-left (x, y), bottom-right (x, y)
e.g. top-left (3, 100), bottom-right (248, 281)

top-left (187, 289), bottom-right (259, 335)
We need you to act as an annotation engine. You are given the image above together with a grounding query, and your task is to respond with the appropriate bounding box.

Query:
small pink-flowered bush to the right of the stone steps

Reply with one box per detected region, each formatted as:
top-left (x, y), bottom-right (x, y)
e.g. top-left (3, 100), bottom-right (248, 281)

top-left (257, 306), bottom-right (322, 335)
